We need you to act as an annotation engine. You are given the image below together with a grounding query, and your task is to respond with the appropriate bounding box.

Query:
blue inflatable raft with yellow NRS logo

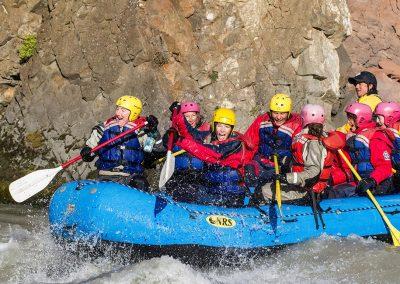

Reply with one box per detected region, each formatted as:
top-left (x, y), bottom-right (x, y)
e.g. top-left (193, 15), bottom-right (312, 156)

top-left (49, 180), bottom-right (400, 258)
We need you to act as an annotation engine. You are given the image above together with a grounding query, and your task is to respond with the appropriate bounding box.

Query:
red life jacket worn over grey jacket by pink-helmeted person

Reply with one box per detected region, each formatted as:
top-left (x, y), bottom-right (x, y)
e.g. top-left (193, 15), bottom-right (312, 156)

top-left (291, 133), bottom-right (335, 192)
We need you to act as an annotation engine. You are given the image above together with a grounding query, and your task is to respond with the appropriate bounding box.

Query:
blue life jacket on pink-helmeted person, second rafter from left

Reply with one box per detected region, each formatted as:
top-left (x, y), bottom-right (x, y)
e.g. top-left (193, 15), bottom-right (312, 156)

top-left (172, 122), bottom-right (210, 171)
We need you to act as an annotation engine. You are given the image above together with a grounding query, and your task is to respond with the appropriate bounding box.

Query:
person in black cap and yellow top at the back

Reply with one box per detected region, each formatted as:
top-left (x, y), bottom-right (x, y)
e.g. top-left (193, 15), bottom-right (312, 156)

top-left (337, 71), bottom-right (382, 134)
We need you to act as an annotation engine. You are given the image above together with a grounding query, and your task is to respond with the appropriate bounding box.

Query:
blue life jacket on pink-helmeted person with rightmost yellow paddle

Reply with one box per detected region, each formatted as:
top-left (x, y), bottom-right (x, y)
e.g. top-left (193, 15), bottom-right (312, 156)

top-left (346, 128), bottom-right (377, 178)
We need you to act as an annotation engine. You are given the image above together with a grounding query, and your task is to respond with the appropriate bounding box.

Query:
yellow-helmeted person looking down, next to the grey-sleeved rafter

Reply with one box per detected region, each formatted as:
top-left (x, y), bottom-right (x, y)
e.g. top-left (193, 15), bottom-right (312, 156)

top-left (239, 94), bottom-right (301, 202)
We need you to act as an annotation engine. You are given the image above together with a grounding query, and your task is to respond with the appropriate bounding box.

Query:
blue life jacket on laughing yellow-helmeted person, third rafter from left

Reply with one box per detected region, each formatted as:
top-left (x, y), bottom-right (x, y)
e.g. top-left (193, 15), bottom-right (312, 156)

top-left (204, 132), bottom-right (244, 195)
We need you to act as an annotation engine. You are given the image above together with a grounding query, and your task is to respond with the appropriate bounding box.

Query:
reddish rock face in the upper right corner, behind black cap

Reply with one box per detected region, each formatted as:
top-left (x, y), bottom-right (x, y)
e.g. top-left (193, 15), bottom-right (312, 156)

top-left (343, 0), bottom-right (400, 113)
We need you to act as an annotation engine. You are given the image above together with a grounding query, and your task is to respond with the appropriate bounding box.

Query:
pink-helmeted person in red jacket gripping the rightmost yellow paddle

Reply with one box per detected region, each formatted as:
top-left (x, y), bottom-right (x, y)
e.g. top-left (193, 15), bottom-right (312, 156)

top-left (336, 102), bottom-right (395, 197)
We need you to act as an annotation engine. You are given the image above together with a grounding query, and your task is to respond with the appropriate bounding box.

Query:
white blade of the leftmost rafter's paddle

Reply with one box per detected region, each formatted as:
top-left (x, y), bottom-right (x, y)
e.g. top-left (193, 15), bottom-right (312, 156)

top-left (9, 166), bottom-right (62, 202)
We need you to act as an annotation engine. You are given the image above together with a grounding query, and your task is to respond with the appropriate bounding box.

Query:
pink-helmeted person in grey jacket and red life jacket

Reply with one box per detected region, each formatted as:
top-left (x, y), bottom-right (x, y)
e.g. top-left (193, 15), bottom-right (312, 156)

top-left (263, 104), bottom-right (352, 201)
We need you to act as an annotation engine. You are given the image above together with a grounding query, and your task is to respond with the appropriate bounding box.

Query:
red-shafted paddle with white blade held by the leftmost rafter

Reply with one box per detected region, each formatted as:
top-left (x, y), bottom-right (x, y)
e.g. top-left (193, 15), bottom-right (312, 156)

top-left (9, 119), bottom-right (147, 202)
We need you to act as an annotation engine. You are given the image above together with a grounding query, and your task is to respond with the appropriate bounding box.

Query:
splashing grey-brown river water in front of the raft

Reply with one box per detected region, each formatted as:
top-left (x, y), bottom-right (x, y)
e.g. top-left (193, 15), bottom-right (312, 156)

top-left (0, 204), bottom-right (400, 283)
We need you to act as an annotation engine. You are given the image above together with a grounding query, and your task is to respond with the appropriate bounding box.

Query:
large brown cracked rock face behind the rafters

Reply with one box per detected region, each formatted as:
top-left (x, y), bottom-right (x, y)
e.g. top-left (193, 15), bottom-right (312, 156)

top-left (0, 0), bottom-right (351, 197)
